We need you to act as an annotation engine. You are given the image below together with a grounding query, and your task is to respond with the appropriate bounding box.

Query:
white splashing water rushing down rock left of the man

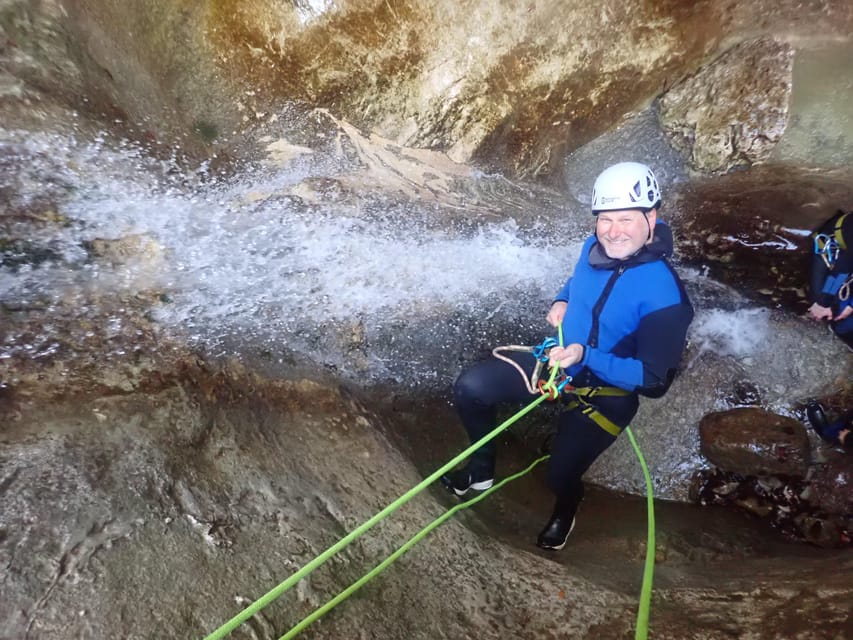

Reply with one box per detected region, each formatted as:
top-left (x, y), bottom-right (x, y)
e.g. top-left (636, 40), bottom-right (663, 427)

top-left (0, 134), bottom-right (580, 380)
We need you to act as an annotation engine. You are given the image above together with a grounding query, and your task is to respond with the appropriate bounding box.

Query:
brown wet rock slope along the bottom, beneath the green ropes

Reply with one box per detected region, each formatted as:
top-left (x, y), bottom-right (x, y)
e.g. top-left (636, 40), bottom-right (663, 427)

top-left (5, 361), bottom-right (850, 638)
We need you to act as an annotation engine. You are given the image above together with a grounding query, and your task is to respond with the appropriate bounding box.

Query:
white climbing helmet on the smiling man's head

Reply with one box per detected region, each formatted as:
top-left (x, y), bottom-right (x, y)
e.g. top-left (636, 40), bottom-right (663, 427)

top-left (592, 162), bottom-right (660, 215)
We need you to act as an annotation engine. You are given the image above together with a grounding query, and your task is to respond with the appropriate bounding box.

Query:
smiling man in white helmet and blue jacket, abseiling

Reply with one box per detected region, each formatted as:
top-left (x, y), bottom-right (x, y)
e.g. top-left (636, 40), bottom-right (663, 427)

top-left (442, 162), bottom-right (693, 549)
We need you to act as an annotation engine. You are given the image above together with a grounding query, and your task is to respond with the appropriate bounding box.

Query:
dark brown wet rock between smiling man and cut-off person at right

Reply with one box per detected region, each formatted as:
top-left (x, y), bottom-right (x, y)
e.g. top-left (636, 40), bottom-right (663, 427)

top-left (668, 165), bottom-right (853, 312)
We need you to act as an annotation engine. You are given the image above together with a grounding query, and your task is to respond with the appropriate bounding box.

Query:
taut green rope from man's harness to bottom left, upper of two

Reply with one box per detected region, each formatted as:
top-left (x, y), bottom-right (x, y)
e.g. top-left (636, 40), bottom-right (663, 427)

top-left (204, 395), bottom-right (547, 640)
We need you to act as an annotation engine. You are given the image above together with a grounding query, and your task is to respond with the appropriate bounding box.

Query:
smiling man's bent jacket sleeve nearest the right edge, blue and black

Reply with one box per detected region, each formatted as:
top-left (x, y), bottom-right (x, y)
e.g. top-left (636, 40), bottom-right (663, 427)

top-left (581, 302), bottom-right (693, 398)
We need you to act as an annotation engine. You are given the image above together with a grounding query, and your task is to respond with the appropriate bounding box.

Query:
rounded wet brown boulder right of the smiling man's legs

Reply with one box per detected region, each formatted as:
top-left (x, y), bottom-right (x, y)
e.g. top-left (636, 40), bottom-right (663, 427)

top-left (699, 408), bottom-right (809, 477)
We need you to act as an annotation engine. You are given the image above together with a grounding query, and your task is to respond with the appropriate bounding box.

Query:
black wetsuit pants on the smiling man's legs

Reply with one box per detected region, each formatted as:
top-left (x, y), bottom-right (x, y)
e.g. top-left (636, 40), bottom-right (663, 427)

top-left (454, 353), bottom-right (639, 514)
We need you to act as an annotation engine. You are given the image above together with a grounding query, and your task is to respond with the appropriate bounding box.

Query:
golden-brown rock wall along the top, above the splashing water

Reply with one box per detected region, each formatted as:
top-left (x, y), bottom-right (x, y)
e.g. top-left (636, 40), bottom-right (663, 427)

top-left (0, 0), bottom-right (853, 180)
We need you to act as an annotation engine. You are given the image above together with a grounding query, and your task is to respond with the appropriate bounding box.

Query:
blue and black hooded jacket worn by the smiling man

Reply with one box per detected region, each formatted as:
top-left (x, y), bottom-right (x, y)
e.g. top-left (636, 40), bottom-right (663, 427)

top-left (556, 222), bottom-right (693, 398)
